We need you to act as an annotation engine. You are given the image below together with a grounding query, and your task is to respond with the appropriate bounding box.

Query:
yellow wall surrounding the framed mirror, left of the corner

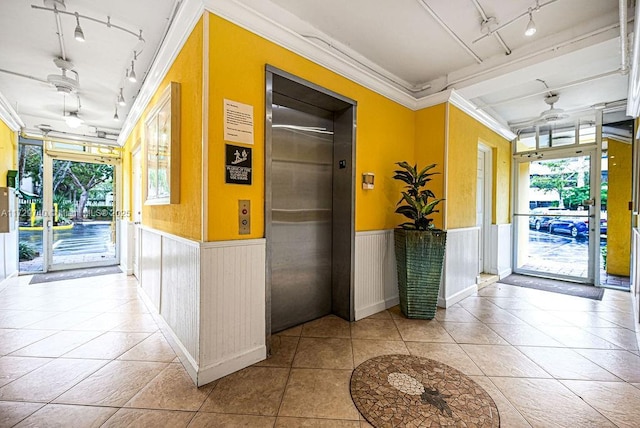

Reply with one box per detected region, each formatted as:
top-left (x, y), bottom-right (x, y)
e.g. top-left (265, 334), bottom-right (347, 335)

top-left (123, 19), bottom-right (203, 240)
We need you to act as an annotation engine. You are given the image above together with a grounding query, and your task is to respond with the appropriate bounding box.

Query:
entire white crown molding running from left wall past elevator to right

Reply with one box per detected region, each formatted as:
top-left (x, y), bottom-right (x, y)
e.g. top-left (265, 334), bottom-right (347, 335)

top-left (117, 0), bottom-right (515, 145)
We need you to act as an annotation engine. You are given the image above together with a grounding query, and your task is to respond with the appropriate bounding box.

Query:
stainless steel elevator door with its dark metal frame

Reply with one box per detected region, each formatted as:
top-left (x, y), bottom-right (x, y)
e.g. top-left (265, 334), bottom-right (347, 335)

top-left (265, 66), bottom-right (356, 336)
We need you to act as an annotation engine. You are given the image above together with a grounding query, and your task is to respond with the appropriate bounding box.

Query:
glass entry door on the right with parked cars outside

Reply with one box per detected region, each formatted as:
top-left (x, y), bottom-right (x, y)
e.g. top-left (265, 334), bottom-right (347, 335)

top-left (514, 151), bottom-right (606, 284)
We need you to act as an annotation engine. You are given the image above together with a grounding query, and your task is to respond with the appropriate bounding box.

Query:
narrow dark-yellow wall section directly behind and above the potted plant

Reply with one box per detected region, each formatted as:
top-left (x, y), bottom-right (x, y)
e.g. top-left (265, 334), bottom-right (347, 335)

top-left (415, 103), bottom-right (447, 228)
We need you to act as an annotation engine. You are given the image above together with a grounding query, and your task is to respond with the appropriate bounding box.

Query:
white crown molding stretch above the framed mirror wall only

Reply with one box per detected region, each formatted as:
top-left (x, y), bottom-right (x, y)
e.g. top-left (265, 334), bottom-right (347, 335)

top-left (118, 0), bottom-right (204, 146)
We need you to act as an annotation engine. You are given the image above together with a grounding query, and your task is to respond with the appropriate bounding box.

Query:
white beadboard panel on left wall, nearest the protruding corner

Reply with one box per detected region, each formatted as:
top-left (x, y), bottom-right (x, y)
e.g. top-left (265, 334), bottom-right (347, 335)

top-left (160, 234), bottom-right (200, 368)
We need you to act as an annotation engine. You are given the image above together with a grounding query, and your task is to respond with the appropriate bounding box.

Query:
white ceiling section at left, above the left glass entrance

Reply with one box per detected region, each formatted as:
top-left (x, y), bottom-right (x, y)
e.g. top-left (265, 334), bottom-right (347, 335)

top-left (0, 0), bottom-right (176, 139)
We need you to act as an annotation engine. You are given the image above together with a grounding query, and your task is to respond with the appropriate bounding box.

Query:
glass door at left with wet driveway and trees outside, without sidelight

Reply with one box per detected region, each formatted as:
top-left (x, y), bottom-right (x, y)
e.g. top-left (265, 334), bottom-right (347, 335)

top-left (45, 156), bottom-right (118, 270)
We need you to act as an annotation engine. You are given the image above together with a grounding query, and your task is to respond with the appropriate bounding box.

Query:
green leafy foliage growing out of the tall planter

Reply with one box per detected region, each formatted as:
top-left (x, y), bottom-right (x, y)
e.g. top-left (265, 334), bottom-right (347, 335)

top-left (393, 162), bottom-right (444, 230)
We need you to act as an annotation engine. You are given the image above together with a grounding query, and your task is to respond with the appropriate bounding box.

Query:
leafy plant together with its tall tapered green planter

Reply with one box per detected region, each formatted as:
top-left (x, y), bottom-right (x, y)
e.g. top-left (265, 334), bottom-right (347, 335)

top-left (393, 162), bottom-right (447, 319)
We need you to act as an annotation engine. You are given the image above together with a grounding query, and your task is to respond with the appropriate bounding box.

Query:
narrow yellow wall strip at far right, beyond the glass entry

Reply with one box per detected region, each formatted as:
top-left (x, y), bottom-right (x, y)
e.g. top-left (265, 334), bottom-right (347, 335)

top-left (607, 139), bottom-right (632, 276)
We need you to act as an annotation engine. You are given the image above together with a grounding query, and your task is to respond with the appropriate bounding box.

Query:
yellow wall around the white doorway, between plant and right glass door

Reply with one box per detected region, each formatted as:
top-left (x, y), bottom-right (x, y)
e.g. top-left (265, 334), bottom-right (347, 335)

top-left (446, 105), bottom-right (511, 229)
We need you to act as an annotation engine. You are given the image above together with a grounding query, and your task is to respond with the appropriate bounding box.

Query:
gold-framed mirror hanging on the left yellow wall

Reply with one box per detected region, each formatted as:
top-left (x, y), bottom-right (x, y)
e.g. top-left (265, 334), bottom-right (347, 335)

top-left (145, 82), bottom-right (180, 205)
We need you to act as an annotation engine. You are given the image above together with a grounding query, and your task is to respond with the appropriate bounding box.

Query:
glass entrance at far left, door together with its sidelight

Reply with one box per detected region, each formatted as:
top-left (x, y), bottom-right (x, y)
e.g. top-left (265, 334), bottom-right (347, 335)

top-left (18, 138), bottom-right (119, 274)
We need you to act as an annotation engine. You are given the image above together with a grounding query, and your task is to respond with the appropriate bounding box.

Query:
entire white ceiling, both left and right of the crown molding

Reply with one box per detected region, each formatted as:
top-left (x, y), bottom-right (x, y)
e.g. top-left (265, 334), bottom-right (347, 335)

top-left (0, 0), bottom-right (635, 144)
